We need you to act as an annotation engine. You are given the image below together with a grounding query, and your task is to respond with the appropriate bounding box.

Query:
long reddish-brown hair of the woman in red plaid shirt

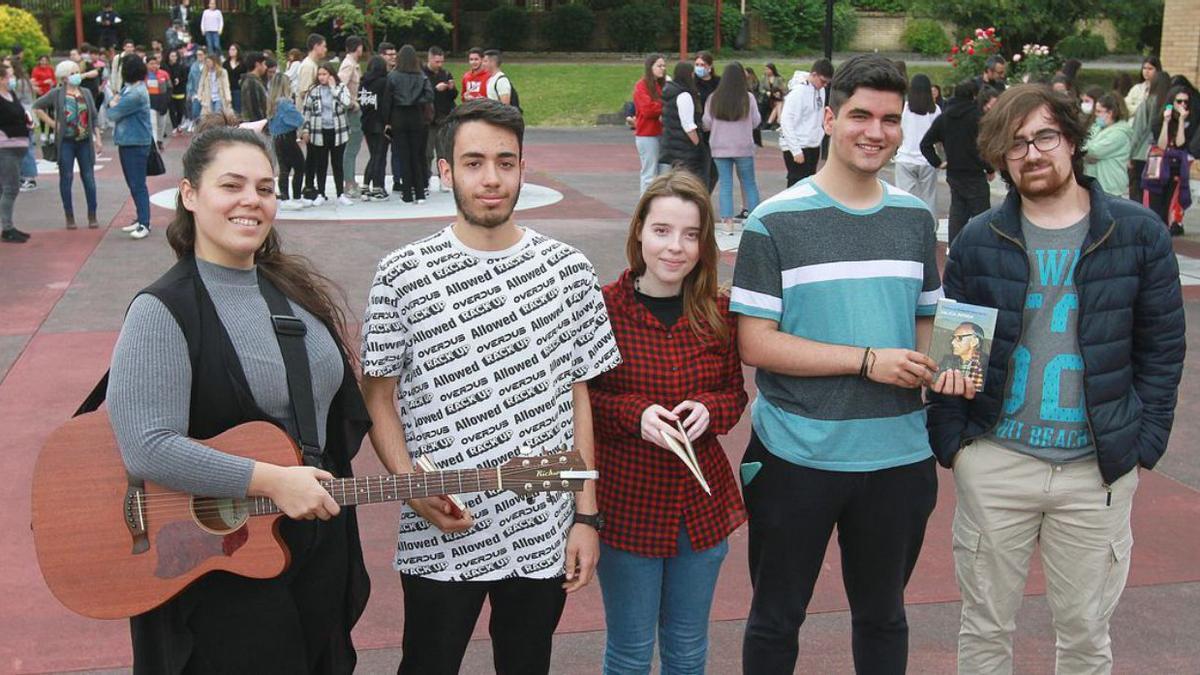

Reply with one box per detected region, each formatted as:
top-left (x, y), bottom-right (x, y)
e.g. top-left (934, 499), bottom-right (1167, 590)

top-left (625, 169), bottom-right (730, 344)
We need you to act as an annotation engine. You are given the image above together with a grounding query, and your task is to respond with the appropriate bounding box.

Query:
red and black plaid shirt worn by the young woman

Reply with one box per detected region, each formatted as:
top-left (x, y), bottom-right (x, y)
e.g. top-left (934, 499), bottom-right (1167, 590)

top-left (588, 270), bottom-right (748, 557)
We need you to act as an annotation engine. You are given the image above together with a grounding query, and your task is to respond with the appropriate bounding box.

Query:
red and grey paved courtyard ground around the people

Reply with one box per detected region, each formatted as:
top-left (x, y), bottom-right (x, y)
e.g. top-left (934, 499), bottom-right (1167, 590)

top-left (0, 129), bottom-right (1200, 674)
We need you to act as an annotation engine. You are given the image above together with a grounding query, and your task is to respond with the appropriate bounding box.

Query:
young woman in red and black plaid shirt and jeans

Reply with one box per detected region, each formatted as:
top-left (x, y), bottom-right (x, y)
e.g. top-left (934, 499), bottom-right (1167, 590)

top-left (588, 171), bottom-right (746, 674)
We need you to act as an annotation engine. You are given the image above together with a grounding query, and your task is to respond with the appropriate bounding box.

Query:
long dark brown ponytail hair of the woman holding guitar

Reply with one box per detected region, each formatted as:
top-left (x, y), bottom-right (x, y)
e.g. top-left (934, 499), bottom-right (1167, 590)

top-left (167, 112), bottom-right (356, 362)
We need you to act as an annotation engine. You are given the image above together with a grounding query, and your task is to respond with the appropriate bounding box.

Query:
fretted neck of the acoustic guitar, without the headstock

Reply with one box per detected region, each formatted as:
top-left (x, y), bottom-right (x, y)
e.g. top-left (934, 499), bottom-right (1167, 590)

top-left (246, 467), bottom-right (503, 515)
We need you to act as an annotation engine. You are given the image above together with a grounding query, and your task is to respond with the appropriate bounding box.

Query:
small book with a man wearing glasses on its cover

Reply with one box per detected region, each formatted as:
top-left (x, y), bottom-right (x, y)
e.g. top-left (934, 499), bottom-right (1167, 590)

top-left (929, 298), bottom-right (997, 390)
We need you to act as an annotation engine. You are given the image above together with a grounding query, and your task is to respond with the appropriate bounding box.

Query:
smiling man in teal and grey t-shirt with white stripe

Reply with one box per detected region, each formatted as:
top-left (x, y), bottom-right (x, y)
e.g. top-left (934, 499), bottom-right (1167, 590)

top-left (731, 54), bottom-right (973, 675)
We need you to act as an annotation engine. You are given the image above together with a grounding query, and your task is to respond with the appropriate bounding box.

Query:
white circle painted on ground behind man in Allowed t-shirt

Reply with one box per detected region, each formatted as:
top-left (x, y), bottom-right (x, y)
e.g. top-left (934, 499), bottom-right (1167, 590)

top-left (150, 177), bottom-right (563, 221)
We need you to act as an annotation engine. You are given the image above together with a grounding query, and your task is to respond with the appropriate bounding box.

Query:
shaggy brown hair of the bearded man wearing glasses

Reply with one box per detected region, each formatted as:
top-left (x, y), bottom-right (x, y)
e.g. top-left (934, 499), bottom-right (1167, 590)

top-left (979, 84), bottom-right (1088, 185)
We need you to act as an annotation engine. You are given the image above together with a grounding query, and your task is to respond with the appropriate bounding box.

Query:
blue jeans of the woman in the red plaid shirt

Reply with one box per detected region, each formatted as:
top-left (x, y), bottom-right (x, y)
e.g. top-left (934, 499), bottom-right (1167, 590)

top-left (596, 527), bottom-right (730, 675)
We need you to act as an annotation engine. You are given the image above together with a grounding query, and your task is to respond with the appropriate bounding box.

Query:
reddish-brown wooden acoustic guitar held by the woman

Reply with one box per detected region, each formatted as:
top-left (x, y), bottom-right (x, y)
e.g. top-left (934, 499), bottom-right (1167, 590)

top-left (32, 411), bottom-right (596, 619)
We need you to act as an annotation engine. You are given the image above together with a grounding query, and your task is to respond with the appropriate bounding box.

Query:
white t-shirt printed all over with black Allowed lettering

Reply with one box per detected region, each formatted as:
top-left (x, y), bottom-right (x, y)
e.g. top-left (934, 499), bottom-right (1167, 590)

top-left (362, 227), bottom-right (620, 581)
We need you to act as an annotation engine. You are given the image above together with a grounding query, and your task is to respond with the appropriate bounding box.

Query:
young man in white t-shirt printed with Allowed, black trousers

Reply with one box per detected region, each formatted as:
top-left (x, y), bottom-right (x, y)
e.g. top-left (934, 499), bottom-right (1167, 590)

top-left (362, 98), bottom-right (620, 674)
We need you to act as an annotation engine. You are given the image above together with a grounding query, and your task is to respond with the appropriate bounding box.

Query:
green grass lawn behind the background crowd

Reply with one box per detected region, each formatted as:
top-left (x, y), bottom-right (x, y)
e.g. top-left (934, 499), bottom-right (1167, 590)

top-left (446, 58), bottom-right (1137, 126)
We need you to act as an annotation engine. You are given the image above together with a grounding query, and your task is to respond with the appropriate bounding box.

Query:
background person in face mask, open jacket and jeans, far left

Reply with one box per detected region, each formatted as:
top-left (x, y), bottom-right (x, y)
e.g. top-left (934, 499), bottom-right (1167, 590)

top-left (34, 61), bottom-right (101, 229)
